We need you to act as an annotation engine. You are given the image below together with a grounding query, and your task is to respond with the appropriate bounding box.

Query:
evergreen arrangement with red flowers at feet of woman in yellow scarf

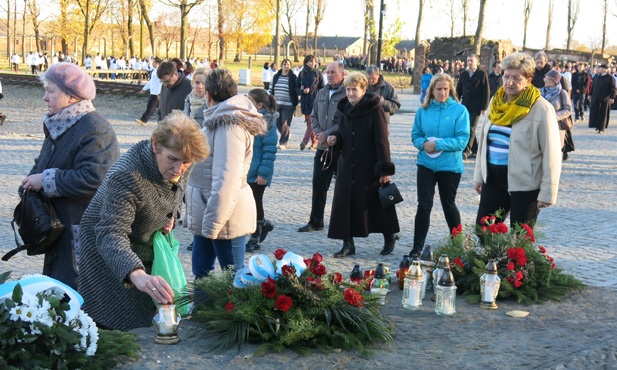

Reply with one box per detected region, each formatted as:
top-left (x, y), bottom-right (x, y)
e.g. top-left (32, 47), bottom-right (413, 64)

top-left (436, 216), bottom-right (584, 304)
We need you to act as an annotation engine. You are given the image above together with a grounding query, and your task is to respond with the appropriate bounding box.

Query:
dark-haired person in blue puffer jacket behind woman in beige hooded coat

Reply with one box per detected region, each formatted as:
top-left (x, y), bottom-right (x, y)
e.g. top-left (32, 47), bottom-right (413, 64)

top-left (246, 89), bottom-right (279, 252)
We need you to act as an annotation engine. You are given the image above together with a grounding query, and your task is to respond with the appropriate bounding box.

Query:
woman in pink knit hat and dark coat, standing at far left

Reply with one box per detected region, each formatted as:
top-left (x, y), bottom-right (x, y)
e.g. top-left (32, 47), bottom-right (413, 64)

top-left (19, 63), bottom-right (120, 289)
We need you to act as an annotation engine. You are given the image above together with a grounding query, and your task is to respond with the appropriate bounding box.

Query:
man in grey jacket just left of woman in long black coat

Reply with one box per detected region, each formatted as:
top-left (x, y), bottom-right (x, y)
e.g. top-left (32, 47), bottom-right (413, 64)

top-left (298, 62), bottom-right (346, 232)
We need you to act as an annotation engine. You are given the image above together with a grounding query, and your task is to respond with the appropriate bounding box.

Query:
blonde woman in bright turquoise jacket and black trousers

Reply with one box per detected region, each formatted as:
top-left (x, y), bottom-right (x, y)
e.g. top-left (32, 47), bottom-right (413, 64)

top-left (410, 74), bottom-right (469, 255)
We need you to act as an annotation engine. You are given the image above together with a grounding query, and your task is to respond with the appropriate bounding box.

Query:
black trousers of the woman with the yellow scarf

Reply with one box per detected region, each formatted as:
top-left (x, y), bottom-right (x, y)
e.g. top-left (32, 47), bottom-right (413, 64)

top-left (476, 164), bottom-right (540, 228)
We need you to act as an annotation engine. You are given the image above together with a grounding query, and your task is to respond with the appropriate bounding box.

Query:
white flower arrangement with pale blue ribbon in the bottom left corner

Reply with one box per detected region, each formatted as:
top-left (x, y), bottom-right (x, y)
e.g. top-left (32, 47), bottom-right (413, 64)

top-left (0, 272), bottom-right (139, 369)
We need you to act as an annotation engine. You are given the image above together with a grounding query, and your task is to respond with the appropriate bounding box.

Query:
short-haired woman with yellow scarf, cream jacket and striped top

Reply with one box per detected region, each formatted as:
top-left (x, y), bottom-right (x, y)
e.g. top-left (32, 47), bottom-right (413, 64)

top-left (474, 53), bottom-right (561, 227)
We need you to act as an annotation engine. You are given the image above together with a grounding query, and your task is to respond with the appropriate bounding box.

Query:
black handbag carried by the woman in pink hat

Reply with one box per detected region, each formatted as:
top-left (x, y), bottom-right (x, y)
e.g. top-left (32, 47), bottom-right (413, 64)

top-left (2, 191), bottom-right (64, 261)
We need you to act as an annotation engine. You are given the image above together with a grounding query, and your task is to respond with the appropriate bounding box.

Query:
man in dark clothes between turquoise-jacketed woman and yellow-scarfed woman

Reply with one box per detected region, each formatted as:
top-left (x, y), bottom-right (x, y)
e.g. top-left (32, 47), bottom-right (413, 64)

top-left (456, 54), bottom-right (491, 159)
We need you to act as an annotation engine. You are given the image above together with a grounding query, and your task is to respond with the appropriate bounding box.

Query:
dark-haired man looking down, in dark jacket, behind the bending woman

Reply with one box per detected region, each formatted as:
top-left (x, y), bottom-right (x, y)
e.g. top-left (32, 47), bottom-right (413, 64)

top-left (156, 62), bottom-right (193, 119)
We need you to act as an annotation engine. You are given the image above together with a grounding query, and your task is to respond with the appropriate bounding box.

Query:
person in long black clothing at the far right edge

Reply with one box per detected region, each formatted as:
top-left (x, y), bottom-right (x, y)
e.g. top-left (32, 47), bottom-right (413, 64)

top-left (587, 64), bottom-right (617, 134)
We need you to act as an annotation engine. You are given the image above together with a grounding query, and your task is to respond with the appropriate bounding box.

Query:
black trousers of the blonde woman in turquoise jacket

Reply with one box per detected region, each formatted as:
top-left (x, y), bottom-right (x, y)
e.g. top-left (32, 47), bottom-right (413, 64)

top-left (413, 165), bottom-right (461, 250)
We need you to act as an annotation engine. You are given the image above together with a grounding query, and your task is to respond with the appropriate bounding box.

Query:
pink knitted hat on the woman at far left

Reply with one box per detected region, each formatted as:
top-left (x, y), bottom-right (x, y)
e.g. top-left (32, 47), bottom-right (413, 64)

top-left (44, 62), bottom-right (96, 100)
